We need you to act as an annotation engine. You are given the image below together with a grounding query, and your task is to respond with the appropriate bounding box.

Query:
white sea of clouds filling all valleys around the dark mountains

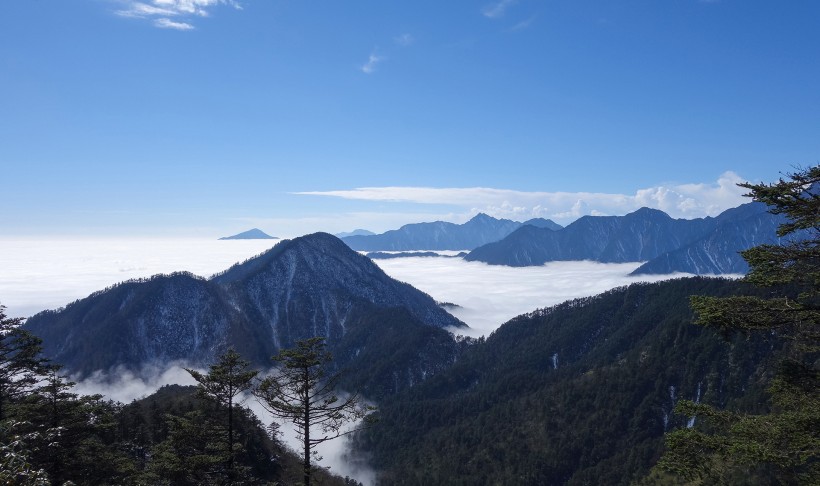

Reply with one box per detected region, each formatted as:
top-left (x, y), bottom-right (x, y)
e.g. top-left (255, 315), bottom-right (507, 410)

top-left (0, 238), bottom-right (700, 484)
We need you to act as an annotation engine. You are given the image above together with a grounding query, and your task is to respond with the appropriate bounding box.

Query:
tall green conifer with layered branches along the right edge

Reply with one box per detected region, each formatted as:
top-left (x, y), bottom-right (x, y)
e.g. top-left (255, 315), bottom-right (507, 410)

top-left (659, 166), bottom-right (820, 484)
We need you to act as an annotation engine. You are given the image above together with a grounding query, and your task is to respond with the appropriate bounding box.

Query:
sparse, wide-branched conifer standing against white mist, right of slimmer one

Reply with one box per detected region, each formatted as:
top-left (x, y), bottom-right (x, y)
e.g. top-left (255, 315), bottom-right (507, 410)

top-left (254, 337), bottom-right (372, 486)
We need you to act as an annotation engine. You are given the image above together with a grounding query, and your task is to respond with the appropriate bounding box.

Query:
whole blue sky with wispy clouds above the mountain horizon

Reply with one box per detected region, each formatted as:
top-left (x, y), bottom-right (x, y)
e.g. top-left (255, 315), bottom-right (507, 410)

top-left (0, 0), bottom-right (820, 237)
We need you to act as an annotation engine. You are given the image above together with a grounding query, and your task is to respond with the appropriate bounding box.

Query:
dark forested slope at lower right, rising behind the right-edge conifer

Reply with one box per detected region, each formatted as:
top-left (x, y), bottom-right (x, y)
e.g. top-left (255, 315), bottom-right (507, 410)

top-left (358, 278), bottom-right (773, 485)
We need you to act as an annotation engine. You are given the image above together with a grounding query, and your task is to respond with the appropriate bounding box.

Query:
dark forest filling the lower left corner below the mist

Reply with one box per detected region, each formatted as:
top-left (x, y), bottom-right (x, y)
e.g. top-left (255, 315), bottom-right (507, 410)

top-left (0, 306), bottom-right (359, 486)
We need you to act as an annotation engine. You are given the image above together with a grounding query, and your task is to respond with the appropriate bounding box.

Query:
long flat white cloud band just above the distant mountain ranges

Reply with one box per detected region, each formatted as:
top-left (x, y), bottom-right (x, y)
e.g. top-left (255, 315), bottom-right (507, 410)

top-left (296, 172), bottom-right (747, 222)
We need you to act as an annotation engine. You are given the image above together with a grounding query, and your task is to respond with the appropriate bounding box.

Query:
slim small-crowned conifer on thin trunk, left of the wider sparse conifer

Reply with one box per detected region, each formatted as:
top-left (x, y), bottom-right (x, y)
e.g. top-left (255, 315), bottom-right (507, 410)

top-left (186, 348), bottom-right (259, 480)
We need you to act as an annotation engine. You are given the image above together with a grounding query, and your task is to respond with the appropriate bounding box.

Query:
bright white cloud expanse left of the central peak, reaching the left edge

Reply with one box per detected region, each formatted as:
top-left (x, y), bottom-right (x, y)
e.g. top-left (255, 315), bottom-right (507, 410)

top-left (0, 237), bottom-right (276, 317)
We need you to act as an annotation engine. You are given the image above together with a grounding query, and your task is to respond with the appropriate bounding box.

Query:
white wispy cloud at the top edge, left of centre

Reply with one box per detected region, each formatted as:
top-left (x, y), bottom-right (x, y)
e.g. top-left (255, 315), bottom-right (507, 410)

top-left (115, 0), bottom-right (242, 30)
